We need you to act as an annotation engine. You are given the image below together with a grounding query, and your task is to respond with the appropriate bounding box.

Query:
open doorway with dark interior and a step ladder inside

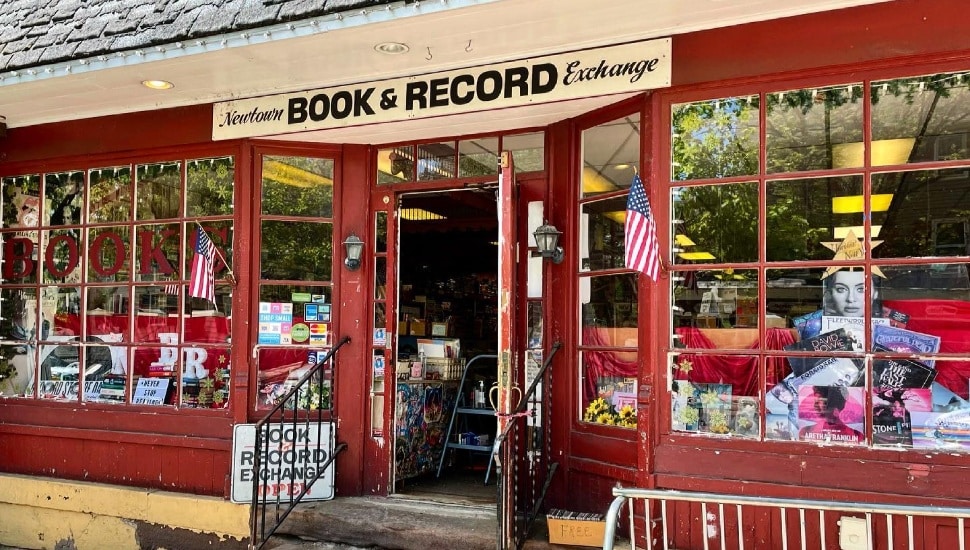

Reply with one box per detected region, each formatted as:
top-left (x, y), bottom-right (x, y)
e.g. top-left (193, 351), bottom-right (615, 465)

top-left (394, 185), bottom-right (499, 505)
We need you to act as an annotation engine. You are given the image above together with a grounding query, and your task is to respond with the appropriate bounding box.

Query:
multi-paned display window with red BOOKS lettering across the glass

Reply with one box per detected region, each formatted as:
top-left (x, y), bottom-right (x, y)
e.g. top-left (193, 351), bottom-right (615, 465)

top-left (0, 157), bottom-right (235, 408)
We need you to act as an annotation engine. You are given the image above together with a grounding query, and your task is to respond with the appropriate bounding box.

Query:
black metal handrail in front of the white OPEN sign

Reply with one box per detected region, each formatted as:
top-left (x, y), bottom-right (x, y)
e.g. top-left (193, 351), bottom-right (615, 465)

top-left (249, 336), bottom-right (350, 550)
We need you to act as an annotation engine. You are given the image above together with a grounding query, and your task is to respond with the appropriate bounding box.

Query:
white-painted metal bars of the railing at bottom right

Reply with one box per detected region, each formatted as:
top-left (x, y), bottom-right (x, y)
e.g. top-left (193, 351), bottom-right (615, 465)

top-left (603, 487), bottom-right (970, 550)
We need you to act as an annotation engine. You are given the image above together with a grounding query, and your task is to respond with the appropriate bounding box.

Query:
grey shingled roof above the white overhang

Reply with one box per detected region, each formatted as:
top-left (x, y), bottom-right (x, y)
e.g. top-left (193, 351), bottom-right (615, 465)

top-left (0, 0), bottom-right (392, 71)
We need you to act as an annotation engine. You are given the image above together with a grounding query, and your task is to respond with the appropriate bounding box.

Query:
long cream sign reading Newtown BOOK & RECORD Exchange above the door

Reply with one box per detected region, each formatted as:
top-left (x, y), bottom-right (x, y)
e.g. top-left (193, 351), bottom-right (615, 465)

top-left (212, 38), bottom-right (671, 140)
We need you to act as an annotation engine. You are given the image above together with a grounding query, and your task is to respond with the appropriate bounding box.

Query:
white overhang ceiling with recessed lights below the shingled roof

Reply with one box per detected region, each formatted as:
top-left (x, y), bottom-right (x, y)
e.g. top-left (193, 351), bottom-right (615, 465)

top-left (0, 0), bottom-right (887, 144)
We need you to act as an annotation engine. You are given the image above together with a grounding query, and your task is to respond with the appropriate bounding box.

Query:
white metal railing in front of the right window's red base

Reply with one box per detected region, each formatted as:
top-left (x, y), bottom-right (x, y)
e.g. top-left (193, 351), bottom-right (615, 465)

top-left (603, 487), bottom-right (970, 550)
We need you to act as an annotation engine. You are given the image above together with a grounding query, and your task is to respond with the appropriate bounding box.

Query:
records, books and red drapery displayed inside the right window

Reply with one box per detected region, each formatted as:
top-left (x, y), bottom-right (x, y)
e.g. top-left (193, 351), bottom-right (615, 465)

top-left (670, 266), bottom-right (970, 451)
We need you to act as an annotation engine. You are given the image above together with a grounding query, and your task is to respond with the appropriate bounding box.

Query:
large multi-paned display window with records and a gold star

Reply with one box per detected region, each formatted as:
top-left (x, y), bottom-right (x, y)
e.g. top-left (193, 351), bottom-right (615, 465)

top-left (668, 73), bottom-right (970, 451)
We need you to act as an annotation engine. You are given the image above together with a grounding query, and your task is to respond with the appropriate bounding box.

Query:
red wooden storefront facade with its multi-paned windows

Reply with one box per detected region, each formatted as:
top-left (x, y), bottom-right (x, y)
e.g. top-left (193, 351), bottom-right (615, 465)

top-left (0, 0), bottom-right (970, 548)
